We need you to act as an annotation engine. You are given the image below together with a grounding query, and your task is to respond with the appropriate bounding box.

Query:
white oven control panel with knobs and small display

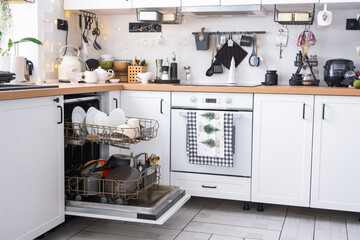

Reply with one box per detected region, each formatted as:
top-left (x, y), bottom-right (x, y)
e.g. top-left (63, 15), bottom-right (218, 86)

top-left (172, 92), bottom-right (253, 109)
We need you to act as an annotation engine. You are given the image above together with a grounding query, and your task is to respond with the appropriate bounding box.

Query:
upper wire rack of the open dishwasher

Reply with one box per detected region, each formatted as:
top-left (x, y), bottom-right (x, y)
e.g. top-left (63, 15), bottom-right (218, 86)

top-left (64, 117), bottom-right (159, 149)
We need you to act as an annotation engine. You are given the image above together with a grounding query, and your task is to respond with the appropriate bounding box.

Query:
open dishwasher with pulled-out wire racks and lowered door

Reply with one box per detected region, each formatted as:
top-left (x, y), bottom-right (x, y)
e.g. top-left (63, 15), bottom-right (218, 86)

top-left (64, 93), bottom-right (190, 224)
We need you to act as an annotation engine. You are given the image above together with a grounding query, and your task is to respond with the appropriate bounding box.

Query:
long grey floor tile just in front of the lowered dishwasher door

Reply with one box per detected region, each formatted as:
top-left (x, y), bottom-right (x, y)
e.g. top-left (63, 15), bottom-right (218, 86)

top-left (84, 221), bottom-right (180, 240)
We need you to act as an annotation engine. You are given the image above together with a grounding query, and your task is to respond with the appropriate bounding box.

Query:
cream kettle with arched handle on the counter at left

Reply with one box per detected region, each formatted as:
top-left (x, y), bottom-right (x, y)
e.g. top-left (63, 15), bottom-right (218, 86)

top-left (58, 45), bottom-right (81, 82)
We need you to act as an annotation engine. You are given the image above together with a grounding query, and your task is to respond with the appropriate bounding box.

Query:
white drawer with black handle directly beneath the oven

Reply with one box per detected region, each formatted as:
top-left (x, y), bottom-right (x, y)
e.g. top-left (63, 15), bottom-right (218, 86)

top-left (171, 172), bottom-right (250, 201)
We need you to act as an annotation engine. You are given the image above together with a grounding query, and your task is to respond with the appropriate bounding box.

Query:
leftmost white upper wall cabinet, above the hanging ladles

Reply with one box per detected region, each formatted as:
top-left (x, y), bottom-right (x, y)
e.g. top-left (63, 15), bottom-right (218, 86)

top-left (64, 0), bottom-right (131, 10)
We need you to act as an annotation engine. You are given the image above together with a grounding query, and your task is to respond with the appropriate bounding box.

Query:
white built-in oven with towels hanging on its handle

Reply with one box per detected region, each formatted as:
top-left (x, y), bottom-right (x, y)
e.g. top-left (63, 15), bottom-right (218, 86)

top-left (171, 92), bottom-right (253, 178)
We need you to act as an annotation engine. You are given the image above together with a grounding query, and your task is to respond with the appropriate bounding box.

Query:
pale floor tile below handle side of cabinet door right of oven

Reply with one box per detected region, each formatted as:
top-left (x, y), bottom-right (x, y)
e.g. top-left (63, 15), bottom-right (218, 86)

top-left (280, 212), bottom-right (315, 240)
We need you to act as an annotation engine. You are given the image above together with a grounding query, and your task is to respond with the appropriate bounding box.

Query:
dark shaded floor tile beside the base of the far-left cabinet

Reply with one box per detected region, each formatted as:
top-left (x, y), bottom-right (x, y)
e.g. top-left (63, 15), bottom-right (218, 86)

top-left (43, 217), bottom-right (97, 240)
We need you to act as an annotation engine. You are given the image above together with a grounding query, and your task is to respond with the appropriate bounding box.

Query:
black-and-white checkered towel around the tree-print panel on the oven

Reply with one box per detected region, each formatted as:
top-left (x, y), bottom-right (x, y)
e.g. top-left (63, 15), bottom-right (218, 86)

top-left (187, 111), bottom-right (234, 167)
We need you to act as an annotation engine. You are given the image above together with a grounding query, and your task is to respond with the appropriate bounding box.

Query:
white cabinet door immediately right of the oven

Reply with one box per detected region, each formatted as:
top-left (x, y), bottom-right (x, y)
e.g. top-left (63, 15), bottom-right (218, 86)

top-left (251, 94), bottom-right (314, 207)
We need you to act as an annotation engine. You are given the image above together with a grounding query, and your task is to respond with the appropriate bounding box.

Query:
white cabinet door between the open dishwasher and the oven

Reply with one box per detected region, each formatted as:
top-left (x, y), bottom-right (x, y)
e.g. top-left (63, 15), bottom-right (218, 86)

top-left (121, 91), bottom-right (170, 185)
